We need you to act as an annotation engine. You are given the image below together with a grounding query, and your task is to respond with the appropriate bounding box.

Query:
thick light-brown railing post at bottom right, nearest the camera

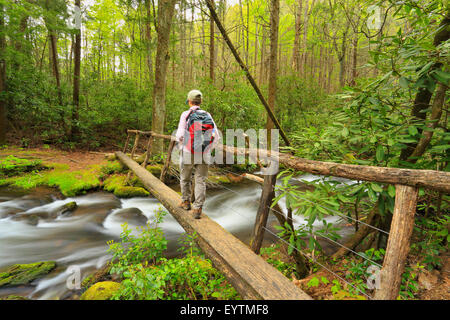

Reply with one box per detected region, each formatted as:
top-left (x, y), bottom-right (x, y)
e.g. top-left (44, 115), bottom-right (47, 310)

top-left (375, 185), bottom-right (418, 300)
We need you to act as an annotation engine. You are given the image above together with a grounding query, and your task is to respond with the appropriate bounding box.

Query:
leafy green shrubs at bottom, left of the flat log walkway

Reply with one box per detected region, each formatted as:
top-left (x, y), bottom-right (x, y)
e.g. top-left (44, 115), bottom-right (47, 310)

top-left (109, 211), bottom-right (239, 300)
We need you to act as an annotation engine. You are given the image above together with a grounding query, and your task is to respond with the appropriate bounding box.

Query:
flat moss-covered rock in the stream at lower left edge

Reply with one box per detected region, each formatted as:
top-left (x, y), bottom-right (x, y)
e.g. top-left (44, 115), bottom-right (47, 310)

top-left (0, 261), bottom-right (56, 287)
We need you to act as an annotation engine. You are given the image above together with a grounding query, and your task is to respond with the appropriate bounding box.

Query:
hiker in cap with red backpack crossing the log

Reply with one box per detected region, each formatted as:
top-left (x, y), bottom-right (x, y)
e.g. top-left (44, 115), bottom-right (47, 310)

top-left (176, 90), bottom-right (219, 219)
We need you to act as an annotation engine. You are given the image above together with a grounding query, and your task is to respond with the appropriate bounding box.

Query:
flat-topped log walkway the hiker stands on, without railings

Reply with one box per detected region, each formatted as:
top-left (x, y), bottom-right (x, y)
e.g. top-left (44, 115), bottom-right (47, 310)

top-left (116, 151), bottom-right (311, 300)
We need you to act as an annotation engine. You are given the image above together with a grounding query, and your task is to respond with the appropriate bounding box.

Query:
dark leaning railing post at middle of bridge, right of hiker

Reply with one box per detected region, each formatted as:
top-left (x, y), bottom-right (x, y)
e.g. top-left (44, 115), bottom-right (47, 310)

top-left (251, 174), bottom-right (277, 254)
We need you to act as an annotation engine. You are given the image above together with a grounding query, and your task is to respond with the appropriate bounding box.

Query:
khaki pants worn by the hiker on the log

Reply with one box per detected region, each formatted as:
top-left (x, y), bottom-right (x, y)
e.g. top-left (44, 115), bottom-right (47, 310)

top-left (180, 151), bottom-right (208, 209)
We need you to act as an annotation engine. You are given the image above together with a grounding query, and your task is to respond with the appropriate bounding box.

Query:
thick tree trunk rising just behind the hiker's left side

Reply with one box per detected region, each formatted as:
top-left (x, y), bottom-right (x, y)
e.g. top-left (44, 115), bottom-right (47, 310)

top-left (152, 0), bottom-right (176, 153)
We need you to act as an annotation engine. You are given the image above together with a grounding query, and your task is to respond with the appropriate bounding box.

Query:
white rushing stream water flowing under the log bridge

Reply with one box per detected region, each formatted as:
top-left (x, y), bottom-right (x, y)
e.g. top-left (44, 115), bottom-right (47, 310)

top-left (0, 175), bottom-right (356, 299)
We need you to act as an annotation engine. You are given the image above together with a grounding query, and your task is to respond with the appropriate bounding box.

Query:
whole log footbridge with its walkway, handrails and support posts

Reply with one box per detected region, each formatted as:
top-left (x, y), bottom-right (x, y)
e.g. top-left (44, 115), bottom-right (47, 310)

top-left (115, 130), bottom-right (450, 300)
